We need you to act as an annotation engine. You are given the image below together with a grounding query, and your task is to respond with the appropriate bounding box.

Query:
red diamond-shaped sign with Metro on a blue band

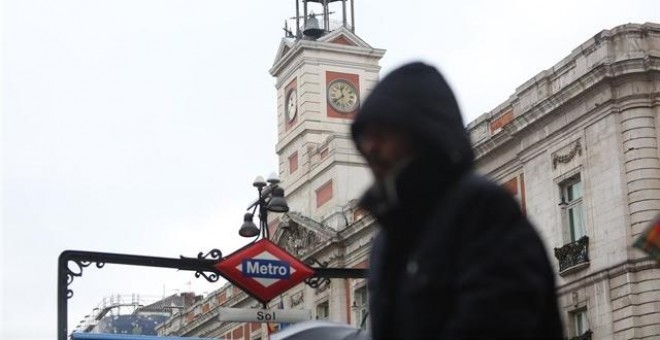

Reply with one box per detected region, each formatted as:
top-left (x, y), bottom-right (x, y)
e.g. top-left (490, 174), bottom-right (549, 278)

top-left (215, 239), bottom-right (314, 303)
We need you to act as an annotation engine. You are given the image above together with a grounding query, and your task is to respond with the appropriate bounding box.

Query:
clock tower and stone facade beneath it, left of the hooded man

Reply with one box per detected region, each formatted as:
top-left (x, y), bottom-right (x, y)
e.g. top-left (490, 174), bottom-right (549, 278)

top-left (159, 0), bottom-right (385, 339)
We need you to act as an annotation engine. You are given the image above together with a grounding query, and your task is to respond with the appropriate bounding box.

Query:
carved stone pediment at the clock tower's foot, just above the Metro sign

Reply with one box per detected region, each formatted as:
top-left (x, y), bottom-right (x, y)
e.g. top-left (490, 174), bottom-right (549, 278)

top-left (273, 212), bottom-right (335, 258)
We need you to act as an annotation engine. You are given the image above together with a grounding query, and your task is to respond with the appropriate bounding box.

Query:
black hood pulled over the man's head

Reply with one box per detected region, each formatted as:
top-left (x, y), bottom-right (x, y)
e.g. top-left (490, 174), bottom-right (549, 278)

top-left (351, 62), bottom-right (474, 173)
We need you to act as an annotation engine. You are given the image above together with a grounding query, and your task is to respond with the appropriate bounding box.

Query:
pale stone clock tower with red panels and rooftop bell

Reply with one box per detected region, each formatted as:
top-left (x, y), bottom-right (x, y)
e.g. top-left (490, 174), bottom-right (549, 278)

top-left (270, 0), bottom-right (385, 230)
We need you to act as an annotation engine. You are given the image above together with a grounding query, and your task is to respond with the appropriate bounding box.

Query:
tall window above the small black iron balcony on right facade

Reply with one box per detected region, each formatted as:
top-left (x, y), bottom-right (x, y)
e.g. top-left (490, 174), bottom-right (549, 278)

top-left (560, 174), bottom-right (587, 242)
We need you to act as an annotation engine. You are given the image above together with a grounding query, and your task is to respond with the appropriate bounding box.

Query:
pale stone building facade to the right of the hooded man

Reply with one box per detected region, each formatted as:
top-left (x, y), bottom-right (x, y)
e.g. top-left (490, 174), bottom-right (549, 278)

top-left (468, 23), bottom-right (660, 339)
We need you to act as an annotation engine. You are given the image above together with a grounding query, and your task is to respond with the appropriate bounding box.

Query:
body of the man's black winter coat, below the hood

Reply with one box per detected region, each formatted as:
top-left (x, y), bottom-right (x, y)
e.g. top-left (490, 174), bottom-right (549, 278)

top-left (368, 175), bottom-right (562, 339)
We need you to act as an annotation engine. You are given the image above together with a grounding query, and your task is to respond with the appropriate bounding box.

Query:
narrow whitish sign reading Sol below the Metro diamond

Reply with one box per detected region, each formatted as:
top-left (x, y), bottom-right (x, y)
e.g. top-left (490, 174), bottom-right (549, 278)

top-left (218, 307), bottom-right (312, 323)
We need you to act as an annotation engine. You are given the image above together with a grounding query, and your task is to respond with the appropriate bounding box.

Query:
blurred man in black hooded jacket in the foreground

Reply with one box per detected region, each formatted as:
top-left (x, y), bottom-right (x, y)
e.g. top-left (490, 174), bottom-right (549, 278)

top-left (351, 62), bottom-right (563, 340)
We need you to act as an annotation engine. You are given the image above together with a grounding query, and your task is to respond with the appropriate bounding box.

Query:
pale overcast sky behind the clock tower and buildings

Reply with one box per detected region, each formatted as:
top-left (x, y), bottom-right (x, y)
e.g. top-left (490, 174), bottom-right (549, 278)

top-left (0, 0), bottom-right (660, 339)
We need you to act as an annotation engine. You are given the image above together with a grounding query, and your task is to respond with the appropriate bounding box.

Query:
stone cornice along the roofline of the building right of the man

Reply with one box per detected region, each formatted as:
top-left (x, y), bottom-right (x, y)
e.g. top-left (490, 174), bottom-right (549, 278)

top-left (468, 23), bottom-right (660, 158)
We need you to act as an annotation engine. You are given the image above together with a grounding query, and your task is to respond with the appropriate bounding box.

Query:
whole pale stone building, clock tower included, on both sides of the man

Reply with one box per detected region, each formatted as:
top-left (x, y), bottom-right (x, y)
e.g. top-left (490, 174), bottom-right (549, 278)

top-left (159, 23), bottom-right (660, 339)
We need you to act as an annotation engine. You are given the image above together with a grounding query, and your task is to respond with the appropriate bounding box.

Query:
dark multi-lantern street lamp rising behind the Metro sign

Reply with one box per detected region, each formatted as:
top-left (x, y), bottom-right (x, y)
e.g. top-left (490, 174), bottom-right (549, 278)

top-left (238, 173), bottom-right (289, 239)
